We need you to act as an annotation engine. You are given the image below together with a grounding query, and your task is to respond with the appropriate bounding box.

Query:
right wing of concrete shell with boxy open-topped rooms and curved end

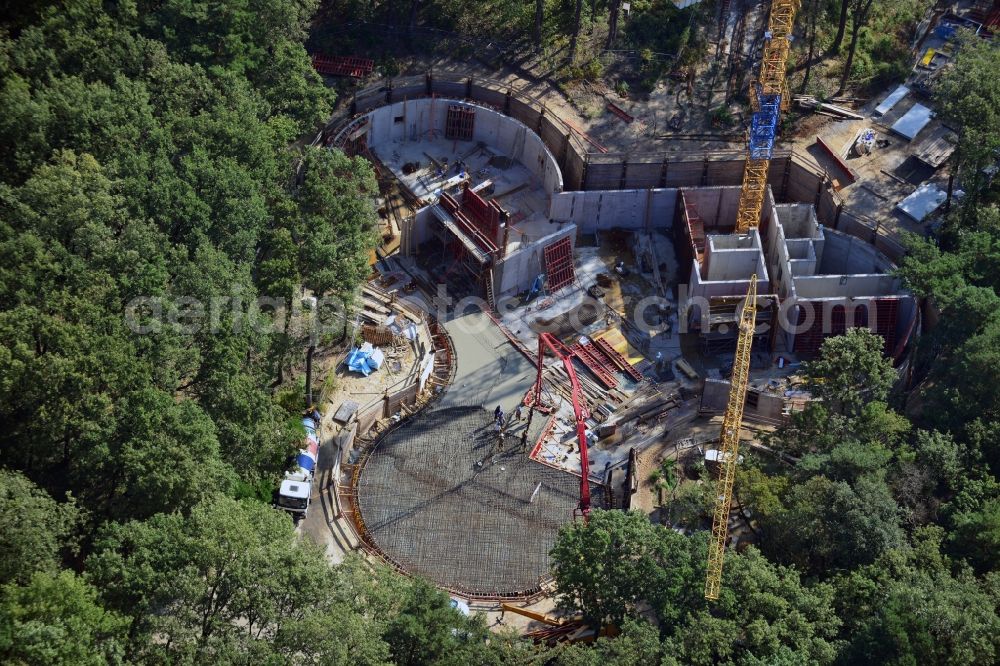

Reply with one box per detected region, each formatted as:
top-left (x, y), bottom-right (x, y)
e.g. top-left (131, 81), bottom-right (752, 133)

top-left (674, 187), bottom-right (917, 360)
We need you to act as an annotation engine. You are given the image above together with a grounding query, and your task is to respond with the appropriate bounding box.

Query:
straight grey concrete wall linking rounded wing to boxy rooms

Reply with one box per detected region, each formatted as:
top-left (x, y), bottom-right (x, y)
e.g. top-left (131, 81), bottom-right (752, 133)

top-left (549, 188), bottom-right (677, 234)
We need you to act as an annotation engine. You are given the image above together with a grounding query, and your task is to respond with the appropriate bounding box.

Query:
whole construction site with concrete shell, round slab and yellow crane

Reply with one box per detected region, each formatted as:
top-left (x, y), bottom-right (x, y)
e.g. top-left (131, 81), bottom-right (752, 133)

top-left (294, 2), bottom-right (968, 628)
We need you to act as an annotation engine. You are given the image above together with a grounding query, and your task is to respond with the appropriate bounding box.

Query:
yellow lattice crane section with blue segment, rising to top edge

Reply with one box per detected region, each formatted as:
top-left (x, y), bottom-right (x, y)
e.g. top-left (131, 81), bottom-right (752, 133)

top-left (736, 0), bottom-right (799, 233)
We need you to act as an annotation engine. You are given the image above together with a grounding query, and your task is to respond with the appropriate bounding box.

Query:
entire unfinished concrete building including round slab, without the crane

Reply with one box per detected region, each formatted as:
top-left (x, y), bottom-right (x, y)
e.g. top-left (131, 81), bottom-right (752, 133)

top-left (326, 76), bottom-right (918, 597)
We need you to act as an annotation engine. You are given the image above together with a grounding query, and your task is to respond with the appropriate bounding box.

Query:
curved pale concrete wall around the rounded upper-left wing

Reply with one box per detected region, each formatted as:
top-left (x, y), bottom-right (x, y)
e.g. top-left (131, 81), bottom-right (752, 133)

top-left (368, 97), bottom-right (563, 194)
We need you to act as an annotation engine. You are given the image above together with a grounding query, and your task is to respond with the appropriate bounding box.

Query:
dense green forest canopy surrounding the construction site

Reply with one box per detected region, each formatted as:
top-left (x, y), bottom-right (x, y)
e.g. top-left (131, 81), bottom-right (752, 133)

top-left (0, 0), bottom-right (1000, 666)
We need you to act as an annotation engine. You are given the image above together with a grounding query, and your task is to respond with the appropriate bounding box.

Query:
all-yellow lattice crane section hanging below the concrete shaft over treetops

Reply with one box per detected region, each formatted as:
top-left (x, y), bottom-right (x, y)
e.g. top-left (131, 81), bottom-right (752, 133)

top-left (705, 273), bottom-right (757, 600)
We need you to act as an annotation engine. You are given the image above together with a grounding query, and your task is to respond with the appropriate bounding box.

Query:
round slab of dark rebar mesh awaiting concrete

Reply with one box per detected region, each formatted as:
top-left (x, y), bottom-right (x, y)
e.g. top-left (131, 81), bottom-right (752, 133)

top-left (358, 407), bottom-right (601, 596)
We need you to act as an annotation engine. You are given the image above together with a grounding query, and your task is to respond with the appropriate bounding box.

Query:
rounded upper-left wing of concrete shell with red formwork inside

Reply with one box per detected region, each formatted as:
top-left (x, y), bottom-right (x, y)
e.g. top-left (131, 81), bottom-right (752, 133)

top-left (337, 97), bottom-right (576, 303)
